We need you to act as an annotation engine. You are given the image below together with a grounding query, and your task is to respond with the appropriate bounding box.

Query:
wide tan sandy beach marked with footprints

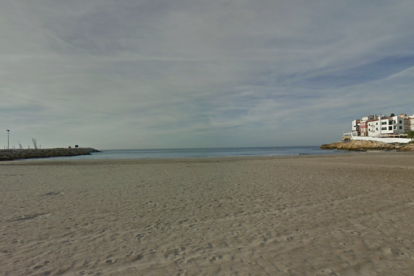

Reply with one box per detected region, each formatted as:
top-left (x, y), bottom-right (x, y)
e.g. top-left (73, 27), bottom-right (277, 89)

top-left (0, 153), bottom-right (414, 275)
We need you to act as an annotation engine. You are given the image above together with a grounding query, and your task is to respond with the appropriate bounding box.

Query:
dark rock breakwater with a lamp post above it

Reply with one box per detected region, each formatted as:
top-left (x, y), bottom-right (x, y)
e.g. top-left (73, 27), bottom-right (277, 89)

top-left (0, 148), bottom-right (99, 161)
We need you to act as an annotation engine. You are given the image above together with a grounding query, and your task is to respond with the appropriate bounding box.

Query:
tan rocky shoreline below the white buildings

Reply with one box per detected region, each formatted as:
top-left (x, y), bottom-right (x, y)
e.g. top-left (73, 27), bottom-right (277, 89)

top-left (321, 141), bottom-right (414, 151)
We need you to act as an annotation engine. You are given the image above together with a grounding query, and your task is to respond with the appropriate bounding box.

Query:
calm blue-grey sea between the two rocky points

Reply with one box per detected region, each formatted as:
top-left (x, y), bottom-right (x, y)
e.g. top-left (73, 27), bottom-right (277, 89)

top-left (42, 146), bottom-right (346, 159)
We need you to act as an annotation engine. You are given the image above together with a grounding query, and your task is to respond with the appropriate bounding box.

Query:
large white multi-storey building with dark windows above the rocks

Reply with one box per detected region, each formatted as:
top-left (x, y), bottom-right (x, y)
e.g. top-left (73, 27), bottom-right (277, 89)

top-left (367, 116), bottom-right (404, 137)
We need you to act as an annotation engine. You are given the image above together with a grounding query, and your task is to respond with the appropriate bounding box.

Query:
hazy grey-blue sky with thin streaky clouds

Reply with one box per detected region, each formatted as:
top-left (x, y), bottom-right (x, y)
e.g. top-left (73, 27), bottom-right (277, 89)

top-left (0, 0), bottom-right (414, 149)
